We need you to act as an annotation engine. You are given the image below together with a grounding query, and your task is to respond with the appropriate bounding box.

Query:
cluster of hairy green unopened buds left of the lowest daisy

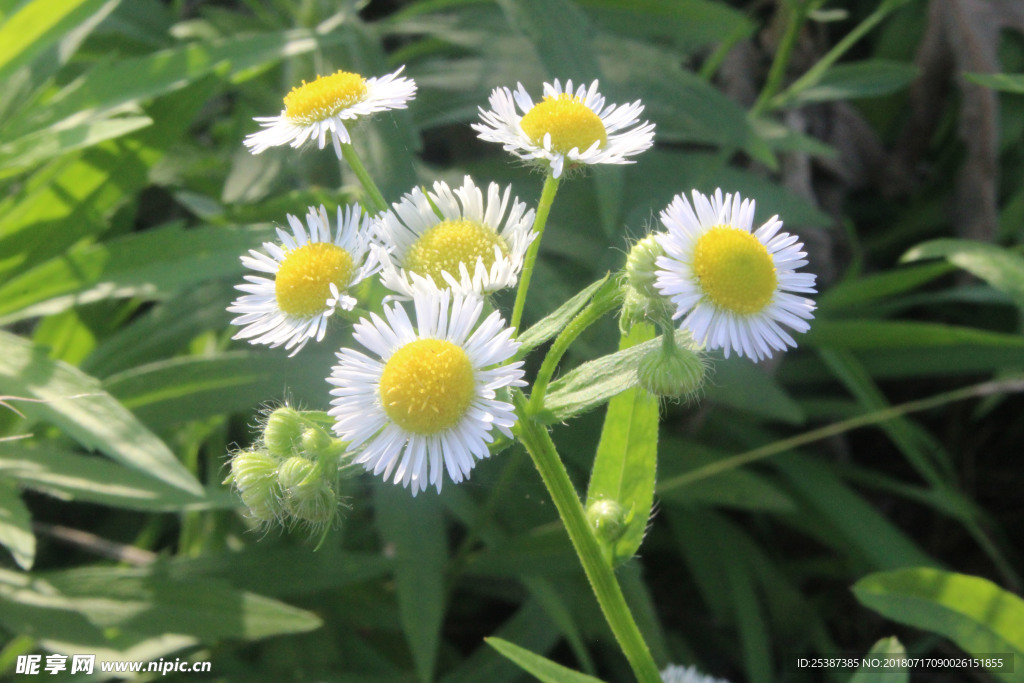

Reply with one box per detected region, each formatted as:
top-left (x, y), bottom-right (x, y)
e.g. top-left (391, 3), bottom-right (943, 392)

top-left (225, 405), bottom-right (348, 530)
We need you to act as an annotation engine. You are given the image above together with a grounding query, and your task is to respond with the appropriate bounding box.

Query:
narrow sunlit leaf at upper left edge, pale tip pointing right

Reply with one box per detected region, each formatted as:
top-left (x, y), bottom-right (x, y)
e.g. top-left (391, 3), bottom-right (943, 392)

top-left (0, 116), bottom-right (153, 177)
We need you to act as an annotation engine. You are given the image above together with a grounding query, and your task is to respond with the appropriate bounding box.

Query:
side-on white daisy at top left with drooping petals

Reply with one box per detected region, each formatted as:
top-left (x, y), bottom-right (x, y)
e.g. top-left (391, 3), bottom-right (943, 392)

top-left (245, 67), bottom-right (416, 159)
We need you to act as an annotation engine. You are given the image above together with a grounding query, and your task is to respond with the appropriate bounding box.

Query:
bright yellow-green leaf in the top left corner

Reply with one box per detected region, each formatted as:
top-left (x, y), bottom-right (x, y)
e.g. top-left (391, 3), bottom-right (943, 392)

top-left (0, 0), bottom-right (115, 81)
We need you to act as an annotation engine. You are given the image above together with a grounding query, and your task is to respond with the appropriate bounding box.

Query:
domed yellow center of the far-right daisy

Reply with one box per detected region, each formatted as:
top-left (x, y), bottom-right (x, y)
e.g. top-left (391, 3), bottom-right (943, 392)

top-left (693, 225), bottom-right (778, 315)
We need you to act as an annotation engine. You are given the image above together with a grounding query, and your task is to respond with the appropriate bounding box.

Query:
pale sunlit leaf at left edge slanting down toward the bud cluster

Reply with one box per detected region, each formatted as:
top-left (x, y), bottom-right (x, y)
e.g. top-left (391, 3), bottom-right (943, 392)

top-left (0, 332), bottom-right (203, 496)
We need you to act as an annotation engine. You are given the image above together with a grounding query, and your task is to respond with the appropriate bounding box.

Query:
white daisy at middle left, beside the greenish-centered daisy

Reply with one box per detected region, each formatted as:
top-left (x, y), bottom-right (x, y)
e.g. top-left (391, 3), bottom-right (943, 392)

top-left (227, 205), bottom-right (380, 355)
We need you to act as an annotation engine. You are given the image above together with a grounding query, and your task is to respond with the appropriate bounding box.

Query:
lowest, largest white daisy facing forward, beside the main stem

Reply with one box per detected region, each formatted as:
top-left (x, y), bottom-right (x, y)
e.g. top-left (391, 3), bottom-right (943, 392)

top-left (328, 287), bottom-right (524, 496)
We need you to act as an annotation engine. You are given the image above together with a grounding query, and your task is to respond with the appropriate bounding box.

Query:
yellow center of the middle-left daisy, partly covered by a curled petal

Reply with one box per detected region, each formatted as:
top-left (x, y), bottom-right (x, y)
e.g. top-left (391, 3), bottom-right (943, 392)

top-left (273, 242), bottom-right (353, 317)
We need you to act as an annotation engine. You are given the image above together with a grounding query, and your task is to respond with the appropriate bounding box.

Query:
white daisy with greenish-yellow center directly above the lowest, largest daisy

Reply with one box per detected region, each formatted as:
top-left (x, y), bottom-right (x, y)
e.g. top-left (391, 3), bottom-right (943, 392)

top-left (377, 175), bottom-right (537, 299)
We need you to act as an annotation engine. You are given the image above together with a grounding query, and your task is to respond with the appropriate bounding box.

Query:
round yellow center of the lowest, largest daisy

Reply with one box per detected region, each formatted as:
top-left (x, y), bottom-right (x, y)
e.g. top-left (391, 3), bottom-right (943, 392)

top-left (380, 339), bottom-right (476, 434)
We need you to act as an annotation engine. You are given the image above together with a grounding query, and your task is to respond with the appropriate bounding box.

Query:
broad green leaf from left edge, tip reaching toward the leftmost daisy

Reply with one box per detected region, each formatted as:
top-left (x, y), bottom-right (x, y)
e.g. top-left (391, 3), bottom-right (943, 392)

top-left (0, 224), bottom-right (270, 323)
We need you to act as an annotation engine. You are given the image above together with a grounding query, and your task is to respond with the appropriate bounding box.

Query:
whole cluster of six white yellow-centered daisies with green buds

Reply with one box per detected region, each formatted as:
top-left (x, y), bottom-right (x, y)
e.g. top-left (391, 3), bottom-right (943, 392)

top-left (228, 69), bottom-right (814, 507)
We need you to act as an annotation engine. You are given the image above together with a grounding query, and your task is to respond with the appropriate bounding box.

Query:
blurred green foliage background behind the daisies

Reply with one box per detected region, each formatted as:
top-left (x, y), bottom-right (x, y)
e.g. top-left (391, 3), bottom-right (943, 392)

top-left (0, 0), bottom-right (1024, 683)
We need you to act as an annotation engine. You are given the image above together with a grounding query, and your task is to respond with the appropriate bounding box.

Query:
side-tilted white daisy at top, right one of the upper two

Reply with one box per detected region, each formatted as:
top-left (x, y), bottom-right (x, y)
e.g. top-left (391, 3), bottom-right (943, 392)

top-left (472, 79), bottom-right (654, 178)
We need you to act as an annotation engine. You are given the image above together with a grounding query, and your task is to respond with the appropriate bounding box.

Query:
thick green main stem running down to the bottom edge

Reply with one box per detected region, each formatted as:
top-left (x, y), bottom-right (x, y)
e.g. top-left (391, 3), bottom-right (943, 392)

top-left (513, 391), bottom-right (662, 683)
